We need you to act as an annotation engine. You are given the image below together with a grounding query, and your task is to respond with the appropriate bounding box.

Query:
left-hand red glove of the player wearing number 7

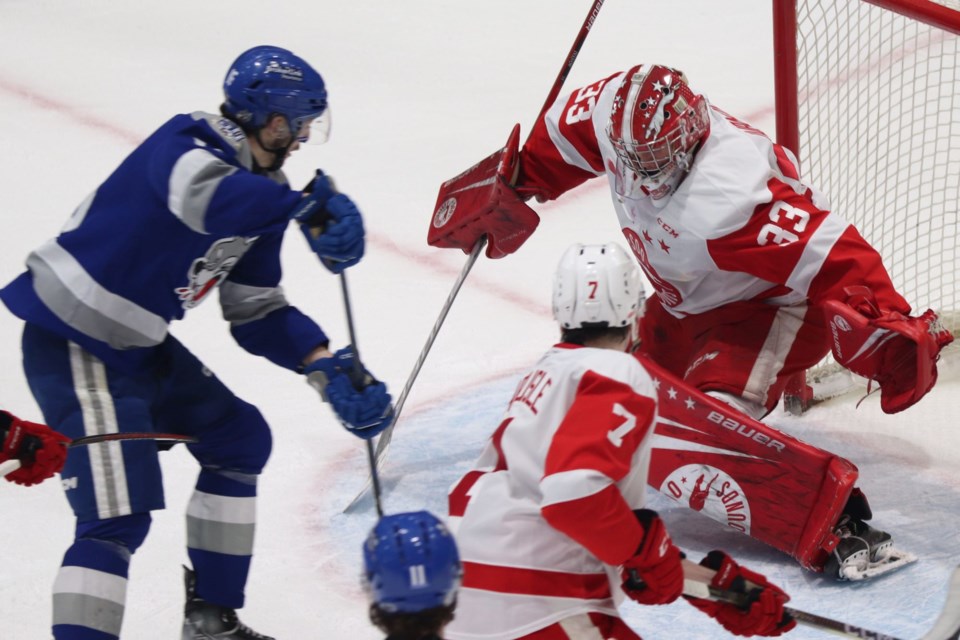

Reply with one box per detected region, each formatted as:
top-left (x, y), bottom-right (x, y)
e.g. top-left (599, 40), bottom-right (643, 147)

top-left (620, 509), bottom-right (683, 604)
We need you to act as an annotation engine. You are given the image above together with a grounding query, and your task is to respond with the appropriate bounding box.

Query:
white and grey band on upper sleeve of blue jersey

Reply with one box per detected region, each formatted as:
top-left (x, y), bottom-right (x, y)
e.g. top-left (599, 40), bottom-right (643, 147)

top-left (167, 147), bottom-right (237, 233)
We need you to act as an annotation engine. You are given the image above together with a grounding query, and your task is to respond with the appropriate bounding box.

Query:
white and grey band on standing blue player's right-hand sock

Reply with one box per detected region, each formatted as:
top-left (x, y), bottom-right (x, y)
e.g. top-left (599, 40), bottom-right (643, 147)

top-left (187, 488), bottom-right (257, 556)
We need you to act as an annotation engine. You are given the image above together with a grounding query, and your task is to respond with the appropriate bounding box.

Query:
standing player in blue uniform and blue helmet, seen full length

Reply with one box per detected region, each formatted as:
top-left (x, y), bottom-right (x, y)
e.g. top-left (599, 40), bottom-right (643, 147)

top-left (0, 46), bottom-right (392, 640)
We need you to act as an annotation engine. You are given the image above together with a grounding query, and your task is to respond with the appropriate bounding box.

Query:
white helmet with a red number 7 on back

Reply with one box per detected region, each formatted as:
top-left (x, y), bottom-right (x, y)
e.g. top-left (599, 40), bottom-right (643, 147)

top-left (553, 242), bottom-right (644, 329)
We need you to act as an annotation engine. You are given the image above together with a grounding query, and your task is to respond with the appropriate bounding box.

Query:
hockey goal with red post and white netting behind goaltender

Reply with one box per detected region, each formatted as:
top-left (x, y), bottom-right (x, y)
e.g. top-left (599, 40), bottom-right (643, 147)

top-left (773, 0), bottom-right (960, 413)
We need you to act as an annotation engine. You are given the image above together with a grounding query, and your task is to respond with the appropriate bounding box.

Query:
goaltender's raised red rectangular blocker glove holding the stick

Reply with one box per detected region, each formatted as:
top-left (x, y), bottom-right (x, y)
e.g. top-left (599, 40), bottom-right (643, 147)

top-left (427, 124), bottom-right (540, 258)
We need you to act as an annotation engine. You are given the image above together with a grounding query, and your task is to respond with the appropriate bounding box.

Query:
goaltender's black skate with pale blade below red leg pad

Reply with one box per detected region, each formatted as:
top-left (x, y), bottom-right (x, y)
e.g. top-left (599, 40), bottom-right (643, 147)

top-left (823, 514), bottom-right (917, 580)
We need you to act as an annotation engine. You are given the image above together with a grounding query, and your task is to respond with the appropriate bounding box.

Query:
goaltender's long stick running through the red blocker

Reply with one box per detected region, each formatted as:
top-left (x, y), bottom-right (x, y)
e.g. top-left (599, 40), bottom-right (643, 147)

top-left (343, 0), bottom-right (604, 513)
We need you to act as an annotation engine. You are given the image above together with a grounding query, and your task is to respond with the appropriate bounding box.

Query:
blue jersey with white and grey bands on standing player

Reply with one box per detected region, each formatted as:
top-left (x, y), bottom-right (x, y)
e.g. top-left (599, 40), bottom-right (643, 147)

top-left (0, 112), bottom-right (327, 371)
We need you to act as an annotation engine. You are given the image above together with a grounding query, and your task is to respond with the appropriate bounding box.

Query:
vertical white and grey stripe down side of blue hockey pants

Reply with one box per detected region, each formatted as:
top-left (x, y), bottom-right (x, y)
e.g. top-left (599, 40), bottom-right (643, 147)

top-left (69, 342), bottom-right (133, 518)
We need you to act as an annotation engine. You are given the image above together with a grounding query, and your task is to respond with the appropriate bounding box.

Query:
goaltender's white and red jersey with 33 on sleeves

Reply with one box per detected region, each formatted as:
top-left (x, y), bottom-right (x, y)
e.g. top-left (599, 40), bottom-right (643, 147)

top-left (517, 73), bottom-right (910, 318)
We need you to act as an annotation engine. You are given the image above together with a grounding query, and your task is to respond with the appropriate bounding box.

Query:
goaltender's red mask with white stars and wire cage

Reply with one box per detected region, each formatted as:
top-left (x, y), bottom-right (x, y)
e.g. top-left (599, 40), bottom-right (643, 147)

top-left (607, 65), bottom-right (710, 201)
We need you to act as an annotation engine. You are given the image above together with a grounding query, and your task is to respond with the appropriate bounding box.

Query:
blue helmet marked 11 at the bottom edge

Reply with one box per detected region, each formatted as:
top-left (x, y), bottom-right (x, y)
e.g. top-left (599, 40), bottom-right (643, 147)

top-left (363, 511), bottom-right (463, 613)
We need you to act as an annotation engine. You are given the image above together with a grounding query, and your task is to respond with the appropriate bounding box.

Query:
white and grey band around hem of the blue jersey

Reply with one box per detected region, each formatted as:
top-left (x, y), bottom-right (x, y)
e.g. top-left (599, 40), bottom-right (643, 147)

top-left (27, 240), bottom-right (167, 349)
